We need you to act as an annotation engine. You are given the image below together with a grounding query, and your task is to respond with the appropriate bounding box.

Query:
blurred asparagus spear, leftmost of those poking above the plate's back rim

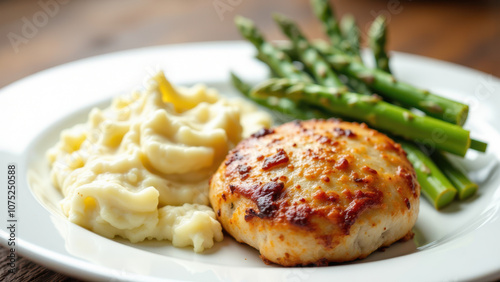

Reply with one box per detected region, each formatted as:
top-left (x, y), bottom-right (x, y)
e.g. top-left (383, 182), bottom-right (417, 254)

top-left (235, 16), bottom-right (312, 82)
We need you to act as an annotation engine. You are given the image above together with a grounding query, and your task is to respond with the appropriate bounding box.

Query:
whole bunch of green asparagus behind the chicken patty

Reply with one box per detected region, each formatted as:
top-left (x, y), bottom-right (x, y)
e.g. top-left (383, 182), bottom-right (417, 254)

top-left (231, 0), bottom-right (487, 209)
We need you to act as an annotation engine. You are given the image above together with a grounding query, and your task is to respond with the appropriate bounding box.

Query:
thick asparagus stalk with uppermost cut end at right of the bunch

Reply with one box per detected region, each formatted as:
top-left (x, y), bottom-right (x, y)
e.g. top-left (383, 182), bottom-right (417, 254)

top-left (325, 53), bottom-right (469, 125)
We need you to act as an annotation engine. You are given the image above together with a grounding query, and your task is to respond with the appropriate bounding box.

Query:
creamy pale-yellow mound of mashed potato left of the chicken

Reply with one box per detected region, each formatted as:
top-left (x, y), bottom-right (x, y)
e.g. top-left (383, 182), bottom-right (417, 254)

top-left (47, 73), bottom-right (271, 252)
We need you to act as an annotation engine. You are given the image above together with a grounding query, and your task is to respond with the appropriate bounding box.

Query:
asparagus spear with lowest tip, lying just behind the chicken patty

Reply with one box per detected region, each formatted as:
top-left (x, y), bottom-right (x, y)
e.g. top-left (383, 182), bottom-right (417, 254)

top-left (230, 72), bottom-right (331, 122)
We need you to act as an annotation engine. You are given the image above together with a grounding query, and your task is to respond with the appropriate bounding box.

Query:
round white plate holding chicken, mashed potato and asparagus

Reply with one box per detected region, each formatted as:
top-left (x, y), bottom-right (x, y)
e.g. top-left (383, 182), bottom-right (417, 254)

top-left (0, 42), bottom-right (500, 281)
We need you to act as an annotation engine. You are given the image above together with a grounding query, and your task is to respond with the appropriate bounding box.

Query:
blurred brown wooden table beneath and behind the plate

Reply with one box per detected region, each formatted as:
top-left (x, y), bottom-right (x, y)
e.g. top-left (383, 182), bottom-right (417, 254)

top-left (0, 0), bottom-right (500, 281)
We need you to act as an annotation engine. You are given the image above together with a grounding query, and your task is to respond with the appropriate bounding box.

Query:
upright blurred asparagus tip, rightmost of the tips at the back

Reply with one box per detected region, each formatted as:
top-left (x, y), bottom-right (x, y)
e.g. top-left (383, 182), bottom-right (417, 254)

top-left (368, 15), bottom-right (391, 73)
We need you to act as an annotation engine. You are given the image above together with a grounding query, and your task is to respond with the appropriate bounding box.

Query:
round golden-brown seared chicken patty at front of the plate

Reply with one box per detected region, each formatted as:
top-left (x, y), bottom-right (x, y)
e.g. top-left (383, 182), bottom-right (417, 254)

top-left (209, 119), bottom-right (420, 266)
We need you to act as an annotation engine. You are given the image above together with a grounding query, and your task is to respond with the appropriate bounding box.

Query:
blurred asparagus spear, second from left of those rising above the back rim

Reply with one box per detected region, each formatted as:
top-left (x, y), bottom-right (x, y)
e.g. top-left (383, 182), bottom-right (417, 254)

top-left (274, 14), bottom-right (343, 87)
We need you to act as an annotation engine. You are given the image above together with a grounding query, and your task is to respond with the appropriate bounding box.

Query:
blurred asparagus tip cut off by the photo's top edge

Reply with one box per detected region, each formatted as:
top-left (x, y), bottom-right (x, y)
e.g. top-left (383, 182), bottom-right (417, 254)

top-left (311, 0), bottom-right (342, 46)
